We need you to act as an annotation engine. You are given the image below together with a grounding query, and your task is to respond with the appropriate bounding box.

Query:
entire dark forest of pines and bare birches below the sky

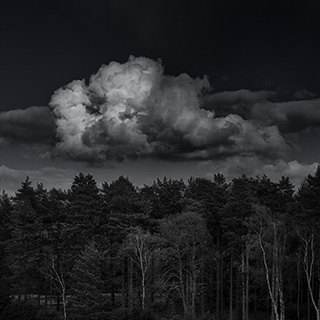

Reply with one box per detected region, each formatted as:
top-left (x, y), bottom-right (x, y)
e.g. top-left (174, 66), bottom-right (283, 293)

top-left (0, 167), bottom-right (320, 320)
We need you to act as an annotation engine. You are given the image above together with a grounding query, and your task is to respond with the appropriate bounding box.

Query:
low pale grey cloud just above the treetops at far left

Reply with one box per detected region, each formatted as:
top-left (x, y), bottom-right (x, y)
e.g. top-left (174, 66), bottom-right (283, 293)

top-left (0, 165), bottom-right (77, 195)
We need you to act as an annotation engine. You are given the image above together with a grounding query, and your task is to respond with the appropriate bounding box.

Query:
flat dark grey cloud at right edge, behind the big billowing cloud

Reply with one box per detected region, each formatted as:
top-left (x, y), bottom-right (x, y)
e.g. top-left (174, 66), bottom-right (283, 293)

top-left (204, 90), bottom-right (320, 133)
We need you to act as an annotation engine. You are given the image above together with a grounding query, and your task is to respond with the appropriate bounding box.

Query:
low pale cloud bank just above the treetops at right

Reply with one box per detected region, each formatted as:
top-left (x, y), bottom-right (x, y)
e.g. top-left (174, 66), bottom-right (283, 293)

top-left (203, 156), bottom-right (320, 187)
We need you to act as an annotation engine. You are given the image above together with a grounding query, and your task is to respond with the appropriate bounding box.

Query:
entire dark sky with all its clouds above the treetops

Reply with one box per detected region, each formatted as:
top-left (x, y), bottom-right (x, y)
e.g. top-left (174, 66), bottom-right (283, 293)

top-left (0, 0), bottom-right (320, 194)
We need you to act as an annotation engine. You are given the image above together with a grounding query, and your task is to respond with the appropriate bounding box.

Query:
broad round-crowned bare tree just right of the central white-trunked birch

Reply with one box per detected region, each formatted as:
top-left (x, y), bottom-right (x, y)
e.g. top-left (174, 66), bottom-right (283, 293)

top-left (162, 212), bottom-right (209, 318)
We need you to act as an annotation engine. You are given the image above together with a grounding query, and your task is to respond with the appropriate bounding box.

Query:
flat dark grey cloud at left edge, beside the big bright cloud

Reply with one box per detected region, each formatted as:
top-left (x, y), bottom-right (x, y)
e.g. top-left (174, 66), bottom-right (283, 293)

top-left (0, 107), bottom-right (55, 145)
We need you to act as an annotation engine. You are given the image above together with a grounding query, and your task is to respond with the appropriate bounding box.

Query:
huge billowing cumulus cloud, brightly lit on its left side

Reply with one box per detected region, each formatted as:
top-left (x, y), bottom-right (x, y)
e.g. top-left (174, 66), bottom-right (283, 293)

top-left (50, 57), bottom-right (288, 164)
